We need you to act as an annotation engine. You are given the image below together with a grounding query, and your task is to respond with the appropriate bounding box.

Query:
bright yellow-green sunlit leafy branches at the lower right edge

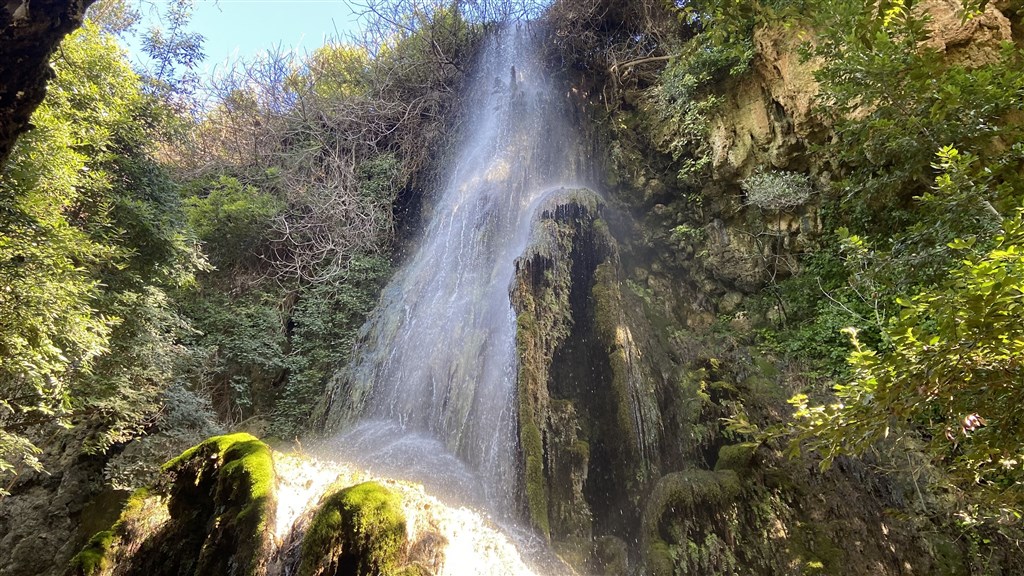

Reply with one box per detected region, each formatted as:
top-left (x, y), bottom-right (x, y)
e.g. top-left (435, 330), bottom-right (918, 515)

top-left (792, 170), bottom-right (1024, 518)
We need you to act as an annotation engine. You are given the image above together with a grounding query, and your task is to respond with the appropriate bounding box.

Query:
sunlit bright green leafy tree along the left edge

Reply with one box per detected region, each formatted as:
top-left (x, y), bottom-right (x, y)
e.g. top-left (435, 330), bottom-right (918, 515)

top-left (0, 23), bottom-right (204, 481)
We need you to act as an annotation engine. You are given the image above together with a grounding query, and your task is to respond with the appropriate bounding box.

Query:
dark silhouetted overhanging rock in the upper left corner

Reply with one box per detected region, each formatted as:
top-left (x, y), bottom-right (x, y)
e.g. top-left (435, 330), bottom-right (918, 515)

top-left (0, 0), bottom-right (95, 167)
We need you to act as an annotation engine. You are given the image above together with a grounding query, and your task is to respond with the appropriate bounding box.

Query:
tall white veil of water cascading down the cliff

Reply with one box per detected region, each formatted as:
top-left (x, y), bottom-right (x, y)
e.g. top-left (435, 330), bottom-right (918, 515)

top-left (323, 26), bottom-right (586, 515)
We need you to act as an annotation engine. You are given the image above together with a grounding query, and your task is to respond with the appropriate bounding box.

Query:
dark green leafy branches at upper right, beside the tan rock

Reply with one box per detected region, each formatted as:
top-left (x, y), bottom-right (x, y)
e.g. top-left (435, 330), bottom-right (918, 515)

top-left (808, 1), bottom-right (1024, 233)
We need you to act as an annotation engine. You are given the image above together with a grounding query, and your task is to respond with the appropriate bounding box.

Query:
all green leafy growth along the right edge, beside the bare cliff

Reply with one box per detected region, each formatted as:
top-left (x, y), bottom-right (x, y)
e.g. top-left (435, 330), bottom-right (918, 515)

top-left (659, 1), bottom-right (1024, 521)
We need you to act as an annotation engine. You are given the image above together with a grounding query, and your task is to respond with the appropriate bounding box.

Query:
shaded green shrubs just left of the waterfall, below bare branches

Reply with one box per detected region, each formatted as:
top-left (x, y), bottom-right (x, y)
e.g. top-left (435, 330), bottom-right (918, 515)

top-left (182, 155), bottom-right (397, 430)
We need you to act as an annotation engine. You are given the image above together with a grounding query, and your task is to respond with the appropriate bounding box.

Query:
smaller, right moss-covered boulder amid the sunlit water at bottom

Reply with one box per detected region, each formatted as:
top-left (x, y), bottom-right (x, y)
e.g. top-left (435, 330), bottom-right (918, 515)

top-left (298, 482), bottom-right (405, 576)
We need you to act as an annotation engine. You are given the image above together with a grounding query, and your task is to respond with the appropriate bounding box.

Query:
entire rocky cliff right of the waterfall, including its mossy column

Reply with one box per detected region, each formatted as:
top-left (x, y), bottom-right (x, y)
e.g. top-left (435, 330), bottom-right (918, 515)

top-left (513, 0), bottom-right (1021, 575)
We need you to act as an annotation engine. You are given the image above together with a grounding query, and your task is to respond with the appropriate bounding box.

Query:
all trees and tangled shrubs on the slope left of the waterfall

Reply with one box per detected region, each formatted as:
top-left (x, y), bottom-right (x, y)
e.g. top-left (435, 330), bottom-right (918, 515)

top-left (0, 0), bottom-right (493, 493)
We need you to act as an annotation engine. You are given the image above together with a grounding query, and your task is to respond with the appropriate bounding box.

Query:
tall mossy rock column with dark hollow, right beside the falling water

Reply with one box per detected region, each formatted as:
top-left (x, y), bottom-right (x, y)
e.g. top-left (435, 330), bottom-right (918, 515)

top-left (512, 190), bottom-right (660, 563)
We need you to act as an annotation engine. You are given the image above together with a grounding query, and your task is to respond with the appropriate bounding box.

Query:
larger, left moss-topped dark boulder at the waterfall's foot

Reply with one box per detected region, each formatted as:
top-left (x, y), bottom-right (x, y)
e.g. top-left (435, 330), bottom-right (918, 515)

top-left (70, 434), bottom-right (276, 576)
